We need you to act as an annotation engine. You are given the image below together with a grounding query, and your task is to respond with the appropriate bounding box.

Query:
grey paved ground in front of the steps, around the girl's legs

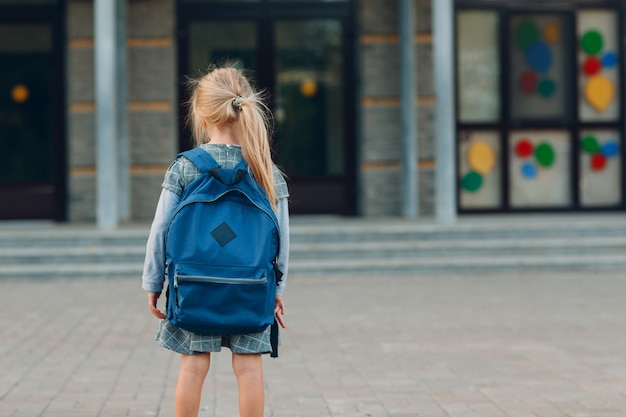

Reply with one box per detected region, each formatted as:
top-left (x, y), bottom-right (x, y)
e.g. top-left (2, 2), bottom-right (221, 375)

top-left (0, 273), bottom-right (626, 417)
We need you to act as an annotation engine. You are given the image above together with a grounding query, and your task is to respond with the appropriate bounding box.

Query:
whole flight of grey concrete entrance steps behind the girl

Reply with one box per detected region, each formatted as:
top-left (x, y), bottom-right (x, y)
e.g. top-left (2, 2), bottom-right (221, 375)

top-left (0, 213), bottom-right (626, 279)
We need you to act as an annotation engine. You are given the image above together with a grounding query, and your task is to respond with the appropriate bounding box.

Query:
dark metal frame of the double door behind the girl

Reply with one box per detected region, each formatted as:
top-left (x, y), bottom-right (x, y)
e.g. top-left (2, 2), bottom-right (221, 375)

top-left (176, 0), bottom-right (358, 215)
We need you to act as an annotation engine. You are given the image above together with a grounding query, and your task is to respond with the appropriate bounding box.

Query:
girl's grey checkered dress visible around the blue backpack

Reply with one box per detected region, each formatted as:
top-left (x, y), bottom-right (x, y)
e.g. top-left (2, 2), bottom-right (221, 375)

top-left (156, 144), bottom-right (289, 355)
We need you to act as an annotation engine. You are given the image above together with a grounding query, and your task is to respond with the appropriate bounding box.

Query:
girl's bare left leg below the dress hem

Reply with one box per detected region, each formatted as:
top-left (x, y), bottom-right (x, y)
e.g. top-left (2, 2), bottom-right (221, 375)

top-left (174, 353), bottom-right (211, 417)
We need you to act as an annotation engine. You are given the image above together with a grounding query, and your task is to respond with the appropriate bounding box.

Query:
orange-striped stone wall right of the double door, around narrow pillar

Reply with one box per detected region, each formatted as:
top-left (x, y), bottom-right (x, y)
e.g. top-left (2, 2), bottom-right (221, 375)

top-left (357, 0), bottom-right (435, 216)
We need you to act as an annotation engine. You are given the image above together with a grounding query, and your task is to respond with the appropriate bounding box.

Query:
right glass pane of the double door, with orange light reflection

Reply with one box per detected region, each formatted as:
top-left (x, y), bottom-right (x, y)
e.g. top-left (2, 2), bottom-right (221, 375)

top-left (274, 19), bottom-right (350, 212)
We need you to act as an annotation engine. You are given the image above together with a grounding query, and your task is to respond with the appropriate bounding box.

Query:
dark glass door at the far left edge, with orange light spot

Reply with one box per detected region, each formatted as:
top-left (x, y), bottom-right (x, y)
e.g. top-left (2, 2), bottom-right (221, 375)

top-left (0, 16), bottom-right (65, 220)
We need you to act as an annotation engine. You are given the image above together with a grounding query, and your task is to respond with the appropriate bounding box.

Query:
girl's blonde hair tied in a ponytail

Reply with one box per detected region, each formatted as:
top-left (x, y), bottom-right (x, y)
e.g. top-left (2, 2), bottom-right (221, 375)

top-left (187, 64), bottom-right (276, 209)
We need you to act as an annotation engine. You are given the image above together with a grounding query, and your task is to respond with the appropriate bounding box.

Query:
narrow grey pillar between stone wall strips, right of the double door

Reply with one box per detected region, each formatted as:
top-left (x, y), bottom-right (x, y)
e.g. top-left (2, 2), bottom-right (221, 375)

top-left (398, 0), bottom-right (419, 218)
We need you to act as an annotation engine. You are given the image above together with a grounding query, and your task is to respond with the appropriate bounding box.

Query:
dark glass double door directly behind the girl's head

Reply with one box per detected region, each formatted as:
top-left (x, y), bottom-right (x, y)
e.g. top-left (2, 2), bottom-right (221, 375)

top-left (179, 3), bottom-right (356, 215)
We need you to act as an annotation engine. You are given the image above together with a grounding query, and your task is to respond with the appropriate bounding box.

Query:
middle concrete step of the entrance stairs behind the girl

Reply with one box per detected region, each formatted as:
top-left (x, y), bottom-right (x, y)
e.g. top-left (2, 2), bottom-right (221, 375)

top-left (0, 236), bottom-right (626, 265)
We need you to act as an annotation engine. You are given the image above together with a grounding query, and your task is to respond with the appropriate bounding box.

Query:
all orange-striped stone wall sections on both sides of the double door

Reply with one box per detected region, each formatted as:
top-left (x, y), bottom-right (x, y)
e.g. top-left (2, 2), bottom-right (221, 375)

top-left (67, 0), bottom-right (434, 222)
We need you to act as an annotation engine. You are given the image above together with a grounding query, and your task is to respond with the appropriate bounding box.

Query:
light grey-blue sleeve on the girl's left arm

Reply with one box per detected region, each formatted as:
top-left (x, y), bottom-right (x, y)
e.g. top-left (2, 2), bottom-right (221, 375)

top-left (141, 188), bottom-right (180, 292)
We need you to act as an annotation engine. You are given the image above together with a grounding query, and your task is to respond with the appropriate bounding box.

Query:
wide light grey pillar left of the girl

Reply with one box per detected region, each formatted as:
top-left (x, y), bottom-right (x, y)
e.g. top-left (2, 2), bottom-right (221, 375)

top-left (94, 0), bottom-right (130, 230)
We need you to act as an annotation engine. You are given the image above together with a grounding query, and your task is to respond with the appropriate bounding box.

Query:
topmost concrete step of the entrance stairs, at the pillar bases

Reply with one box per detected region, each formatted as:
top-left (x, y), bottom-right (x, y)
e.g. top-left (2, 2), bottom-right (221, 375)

top-left (0, 214), bottom-right (626, 248)
